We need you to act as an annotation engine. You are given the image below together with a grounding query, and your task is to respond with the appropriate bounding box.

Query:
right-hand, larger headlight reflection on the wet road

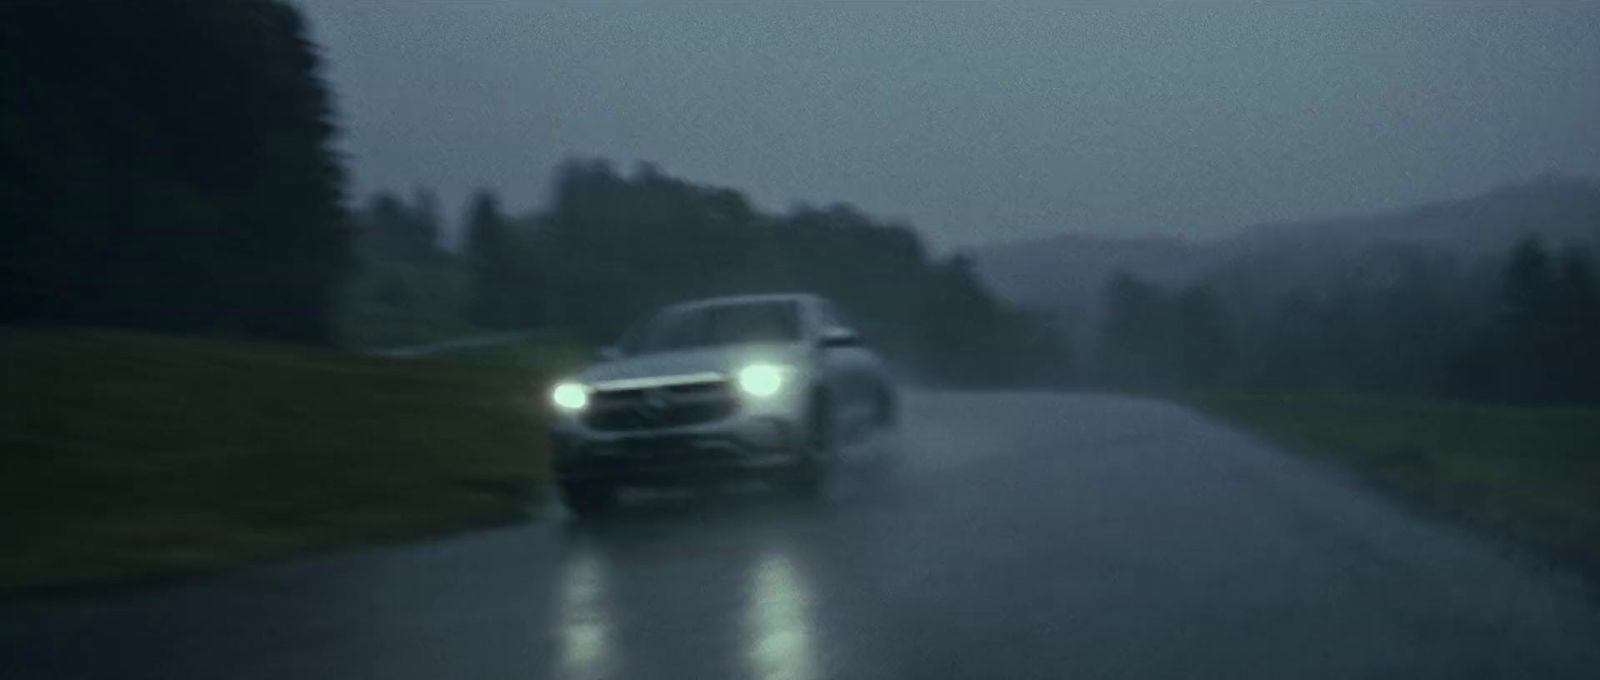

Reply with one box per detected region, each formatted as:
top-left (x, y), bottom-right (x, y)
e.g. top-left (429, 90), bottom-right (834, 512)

top-left (744, 552), bottom-right (818, 680)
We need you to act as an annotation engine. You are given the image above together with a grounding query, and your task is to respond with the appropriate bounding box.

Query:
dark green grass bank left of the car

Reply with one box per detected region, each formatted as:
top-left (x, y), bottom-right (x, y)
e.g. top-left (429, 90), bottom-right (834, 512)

top-left (0, 330), bottom-right (573, 590)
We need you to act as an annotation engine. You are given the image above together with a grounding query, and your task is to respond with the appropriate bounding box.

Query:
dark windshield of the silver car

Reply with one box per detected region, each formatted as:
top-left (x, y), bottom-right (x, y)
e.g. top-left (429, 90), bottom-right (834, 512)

top-left (621, 301), bottom-right (800, 354)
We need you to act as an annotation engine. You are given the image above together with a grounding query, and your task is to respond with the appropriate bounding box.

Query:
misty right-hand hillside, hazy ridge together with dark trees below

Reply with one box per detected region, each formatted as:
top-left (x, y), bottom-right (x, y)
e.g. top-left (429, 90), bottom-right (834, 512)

top-left (974, 176), bottom-right (1600, 402)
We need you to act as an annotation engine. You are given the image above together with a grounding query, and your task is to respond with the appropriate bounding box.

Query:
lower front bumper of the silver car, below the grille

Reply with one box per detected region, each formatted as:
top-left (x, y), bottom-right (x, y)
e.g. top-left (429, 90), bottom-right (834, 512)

top-left (550, 413), bottom-right (805, 486)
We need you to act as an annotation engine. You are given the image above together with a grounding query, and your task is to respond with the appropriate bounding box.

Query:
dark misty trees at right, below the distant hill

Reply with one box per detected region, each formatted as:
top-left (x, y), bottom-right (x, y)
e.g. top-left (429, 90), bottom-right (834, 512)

top-left (1083, 238), bottom-right (1600, 403)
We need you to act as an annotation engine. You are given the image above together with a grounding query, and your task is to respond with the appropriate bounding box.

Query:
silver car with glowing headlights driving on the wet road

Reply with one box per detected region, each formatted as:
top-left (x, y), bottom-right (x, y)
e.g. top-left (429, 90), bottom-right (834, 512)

top-left (550, 293), bottom-right (899, 515)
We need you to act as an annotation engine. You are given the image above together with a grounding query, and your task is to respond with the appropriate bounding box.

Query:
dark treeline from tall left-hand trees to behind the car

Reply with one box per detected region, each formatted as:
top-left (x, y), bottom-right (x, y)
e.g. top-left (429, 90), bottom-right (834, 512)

top-left (0, 0), bottom-right (1067, 384)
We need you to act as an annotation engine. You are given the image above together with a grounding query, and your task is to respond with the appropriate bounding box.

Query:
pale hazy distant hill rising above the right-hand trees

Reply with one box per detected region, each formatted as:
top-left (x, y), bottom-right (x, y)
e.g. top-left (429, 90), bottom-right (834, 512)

top-left (971, 176), bottom-right (1600, 330)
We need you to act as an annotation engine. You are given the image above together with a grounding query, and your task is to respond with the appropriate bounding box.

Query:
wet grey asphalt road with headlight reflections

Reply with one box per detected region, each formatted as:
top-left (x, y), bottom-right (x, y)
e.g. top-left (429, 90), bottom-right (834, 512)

top-left (0, 395), bottom-right (1600, 680)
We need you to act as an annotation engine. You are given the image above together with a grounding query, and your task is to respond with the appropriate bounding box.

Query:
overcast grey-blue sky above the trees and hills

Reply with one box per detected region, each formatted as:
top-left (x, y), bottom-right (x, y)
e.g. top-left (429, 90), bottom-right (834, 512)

top-left (296, 0), bottom-right (1600, 245)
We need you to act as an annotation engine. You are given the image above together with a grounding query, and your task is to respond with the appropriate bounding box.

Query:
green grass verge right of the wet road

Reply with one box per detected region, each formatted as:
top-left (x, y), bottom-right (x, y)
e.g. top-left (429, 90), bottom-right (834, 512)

top-left (1186, 395), bottom-right (1600, 566)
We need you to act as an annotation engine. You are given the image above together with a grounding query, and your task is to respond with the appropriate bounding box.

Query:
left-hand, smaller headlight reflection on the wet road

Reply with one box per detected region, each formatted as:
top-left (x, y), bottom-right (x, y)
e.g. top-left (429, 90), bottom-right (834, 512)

top-left (557, 550), bottom-right (616, 678)
